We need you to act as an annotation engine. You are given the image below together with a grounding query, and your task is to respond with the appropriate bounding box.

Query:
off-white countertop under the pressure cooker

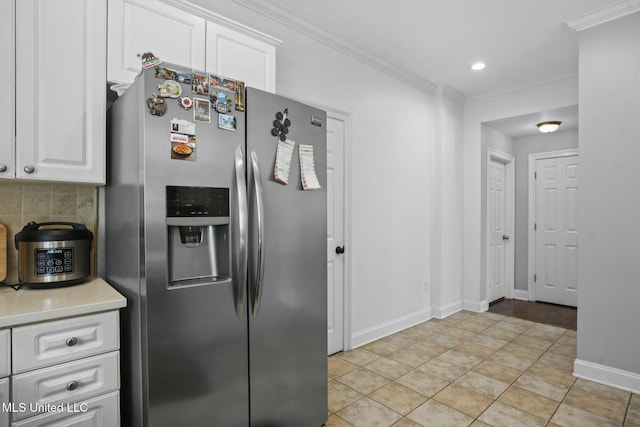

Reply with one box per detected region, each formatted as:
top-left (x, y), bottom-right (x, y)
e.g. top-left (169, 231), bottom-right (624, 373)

top-left (0, 278), bottom-right (127, 328)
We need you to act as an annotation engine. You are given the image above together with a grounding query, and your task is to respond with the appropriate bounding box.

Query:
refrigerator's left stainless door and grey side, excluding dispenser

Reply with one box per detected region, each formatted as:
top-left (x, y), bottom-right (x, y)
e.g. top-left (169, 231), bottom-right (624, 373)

top-left (105, 63), bottom-right (249, 427)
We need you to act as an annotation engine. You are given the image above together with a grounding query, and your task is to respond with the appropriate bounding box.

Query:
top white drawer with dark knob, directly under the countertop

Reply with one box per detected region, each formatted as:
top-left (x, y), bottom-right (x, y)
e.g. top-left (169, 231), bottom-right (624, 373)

top-left (12, 311), bottom-right (120, 374)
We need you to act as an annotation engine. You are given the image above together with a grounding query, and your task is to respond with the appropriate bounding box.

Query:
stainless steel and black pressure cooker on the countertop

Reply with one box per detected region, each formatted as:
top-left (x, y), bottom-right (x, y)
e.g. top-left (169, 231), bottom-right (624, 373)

top-left (15, 222), bottom-right (93, 287)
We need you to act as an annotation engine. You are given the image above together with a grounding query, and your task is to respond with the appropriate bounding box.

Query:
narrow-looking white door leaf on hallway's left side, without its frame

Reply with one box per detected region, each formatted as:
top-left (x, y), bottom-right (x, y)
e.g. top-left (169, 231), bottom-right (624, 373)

top-left (487, 159), bottom-right (509, 302)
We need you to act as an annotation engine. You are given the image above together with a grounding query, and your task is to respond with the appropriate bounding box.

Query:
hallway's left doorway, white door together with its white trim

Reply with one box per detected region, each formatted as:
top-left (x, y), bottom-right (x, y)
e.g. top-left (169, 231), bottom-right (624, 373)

top-left (487, 148), bottom-right (515, 303)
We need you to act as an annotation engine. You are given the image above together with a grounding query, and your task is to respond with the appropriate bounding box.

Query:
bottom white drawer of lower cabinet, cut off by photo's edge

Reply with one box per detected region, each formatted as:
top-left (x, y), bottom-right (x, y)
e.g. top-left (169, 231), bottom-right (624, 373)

top-left (12, 391), bottom-right (120, 427)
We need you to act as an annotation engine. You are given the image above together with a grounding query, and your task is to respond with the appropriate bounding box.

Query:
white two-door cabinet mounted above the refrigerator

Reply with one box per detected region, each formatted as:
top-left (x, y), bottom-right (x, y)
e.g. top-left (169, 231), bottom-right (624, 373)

top-left (108, 0), bottom-right (280, 92)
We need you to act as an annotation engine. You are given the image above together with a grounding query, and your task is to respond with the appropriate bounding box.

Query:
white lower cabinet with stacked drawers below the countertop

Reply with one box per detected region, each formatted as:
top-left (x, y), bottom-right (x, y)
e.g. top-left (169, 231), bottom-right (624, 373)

top-left (6, 311), bottom-right (120, 427)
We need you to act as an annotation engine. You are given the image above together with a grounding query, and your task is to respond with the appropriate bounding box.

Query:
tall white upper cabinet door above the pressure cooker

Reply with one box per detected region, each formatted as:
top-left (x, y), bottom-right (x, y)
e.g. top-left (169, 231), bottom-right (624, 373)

top-left (16, 0), bottom-right (107, 184)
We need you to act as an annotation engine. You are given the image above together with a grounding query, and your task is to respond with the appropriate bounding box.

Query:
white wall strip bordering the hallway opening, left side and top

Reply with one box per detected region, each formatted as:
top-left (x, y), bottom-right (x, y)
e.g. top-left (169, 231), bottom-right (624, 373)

top-left (462, 79), bottom-right (578, 311)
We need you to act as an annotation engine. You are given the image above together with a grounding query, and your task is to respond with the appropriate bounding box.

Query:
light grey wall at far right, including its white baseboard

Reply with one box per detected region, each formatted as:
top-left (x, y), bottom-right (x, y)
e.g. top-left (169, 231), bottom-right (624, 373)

top-left (575, 12), bottom-right (640, 393)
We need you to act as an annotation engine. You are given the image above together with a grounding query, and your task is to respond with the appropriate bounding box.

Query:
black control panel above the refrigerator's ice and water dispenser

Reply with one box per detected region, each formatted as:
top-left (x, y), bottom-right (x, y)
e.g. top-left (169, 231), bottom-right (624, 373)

top-left (167, 186), bottom-right (229, 218)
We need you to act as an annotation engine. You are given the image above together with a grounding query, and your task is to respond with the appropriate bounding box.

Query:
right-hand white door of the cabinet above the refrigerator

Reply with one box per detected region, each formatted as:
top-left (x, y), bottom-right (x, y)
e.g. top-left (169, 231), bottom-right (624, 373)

top-left (206, 22), bottom-right (276, 93)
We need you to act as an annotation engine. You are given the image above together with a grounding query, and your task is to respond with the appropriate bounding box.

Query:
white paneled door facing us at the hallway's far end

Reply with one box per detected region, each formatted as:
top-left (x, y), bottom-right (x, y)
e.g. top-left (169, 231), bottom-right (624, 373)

top-left (534, 156), bottom-right (578, 307)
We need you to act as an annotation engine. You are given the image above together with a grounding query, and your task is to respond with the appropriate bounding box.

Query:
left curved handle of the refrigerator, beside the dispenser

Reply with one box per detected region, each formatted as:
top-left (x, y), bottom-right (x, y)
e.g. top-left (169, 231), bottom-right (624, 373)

top-left (232, 146), bottom-right (249, 320)
